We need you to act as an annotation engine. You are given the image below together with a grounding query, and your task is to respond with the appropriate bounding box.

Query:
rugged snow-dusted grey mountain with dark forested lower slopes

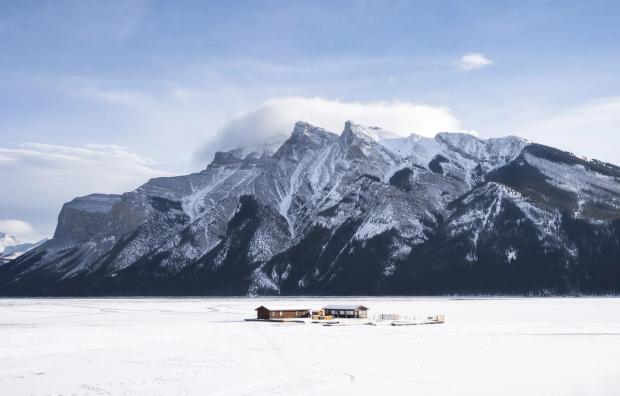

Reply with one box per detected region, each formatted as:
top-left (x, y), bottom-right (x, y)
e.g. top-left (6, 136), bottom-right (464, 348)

top-left (0, 122), bottom-right (620, 295)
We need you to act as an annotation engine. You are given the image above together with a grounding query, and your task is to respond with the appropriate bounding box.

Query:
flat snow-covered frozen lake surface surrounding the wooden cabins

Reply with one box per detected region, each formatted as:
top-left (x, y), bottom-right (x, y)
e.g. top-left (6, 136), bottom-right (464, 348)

top-left (0, 298), bottom-right (620, 396)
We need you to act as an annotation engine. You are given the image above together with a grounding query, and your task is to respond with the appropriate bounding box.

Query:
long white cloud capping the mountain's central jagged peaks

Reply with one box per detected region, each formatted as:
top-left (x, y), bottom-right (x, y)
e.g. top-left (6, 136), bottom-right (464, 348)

top-left (196, 97), bottom-right (461, 163)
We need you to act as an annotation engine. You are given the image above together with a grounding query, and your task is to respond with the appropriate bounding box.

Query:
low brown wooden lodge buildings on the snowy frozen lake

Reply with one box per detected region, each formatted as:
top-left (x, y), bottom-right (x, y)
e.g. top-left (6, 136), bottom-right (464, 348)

top-left (255, 305), bottom-right (368, 320)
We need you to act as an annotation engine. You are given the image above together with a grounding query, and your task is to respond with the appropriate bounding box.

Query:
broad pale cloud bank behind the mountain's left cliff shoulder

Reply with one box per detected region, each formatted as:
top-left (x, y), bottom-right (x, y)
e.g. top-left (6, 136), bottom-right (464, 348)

top-left (0, 143), bottom-right (171, 240)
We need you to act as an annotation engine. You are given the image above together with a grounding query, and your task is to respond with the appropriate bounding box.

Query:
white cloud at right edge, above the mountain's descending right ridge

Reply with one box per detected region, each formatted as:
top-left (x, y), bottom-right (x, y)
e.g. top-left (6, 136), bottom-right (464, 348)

top-left (516, 96), bottom-right (620, 165)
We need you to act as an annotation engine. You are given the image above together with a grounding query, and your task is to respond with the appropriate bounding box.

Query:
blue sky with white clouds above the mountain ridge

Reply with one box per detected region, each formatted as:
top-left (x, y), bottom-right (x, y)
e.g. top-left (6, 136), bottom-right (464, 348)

top-left (0, 0), bottom-right (620, 241)
